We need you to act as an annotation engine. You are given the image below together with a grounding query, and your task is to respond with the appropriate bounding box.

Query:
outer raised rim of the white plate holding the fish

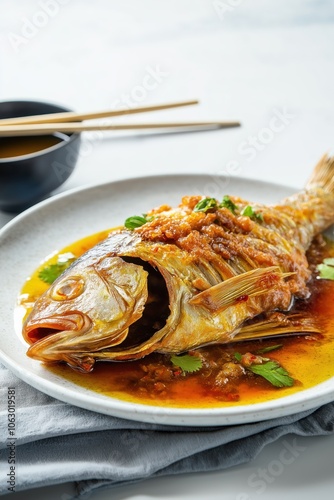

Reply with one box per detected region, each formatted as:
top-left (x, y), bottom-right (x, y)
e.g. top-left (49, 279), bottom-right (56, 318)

top-left (0, 172), bottom-right (334, 427)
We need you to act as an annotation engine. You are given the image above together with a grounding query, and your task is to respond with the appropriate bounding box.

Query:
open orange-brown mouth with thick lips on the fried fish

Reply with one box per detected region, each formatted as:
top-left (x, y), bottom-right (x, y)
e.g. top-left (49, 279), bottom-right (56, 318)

top-left (23, 311), bottom-right (92, 344)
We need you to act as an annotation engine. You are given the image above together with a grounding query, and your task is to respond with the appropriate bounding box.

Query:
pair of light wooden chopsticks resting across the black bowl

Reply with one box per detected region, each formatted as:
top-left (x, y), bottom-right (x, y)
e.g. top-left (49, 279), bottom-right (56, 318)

top-left (0, 100), bottom-right (240, 137)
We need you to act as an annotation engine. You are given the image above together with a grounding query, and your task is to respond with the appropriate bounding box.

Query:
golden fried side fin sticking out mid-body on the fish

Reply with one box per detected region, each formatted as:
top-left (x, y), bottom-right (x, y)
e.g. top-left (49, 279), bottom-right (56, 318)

top-left (189, 266), bottom-right (293, 312)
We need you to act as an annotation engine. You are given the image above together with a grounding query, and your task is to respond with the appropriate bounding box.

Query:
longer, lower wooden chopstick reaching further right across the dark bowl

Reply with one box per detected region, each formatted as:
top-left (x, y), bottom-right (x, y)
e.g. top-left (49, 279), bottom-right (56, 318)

top-left (0, 121), bottom-right (240, 137)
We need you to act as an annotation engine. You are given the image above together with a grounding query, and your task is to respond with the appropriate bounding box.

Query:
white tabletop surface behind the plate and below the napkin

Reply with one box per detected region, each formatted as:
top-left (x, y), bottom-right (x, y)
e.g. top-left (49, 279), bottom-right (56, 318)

top-left (0, 0), bottom-right (334, 500)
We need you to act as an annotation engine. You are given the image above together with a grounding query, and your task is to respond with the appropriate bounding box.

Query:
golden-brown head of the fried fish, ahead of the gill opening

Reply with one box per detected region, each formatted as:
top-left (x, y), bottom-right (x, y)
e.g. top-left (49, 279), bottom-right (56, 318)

top-left (23, 256), bottom-right (148, 371)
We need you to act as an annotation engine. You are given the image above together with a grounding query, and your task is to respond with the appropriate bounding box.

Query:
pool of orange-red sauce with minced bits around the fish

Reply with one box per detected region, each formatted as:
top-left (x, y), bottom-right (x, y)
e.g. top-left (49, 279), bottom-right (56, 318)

top-left (16, 230), bottom-right (334, 408)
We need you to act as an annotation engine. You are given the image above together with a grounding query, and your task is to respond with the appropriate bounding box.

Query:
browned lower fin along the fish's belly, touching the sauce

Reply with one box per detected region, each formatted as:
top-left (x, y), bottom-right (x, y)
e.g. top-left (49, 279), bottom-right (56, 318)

top-left (233, 313), bottom-right (321, 342)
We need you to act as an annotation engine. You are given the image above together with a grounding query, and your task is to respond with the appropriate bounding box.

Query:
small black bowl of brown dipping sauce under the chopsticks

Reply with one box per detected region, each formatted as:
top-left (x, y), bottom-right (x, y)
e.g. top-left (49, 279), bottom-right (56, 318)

top-left (0, 101), bottom-right (81, 212)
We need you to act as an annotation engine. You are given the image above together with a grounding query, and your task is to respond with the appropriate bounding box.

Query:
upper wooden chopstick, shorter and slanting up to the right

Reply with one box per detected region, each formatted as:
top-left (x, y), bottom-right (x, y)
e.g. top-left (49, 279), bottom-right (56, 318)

top-left (0, 100), bottom-right (198, 126)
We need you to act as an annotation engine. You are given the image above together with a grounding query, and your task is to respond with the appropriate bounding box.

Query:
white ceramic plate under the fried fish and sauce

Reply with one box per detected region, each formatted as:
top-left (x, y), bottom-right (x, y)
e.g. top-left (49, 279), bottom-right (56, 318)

top-left (0, 175), bottom-right (334, 426)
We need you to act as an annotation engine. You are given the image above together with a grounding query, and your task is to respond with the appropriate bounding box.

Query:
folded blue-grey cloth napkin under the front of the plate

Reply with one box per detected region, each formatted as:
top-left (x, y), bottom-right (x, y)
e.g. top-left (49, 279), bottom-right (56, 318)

top-left (0, 364), bottom-right (334, 498)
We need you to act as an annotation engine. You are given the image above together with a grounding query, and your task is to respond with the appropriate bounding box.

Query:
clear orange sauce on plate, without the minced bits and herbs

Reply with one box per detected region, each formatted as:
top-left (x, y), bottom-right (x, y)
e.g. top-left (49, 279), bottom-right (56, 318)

top-left (19, 231), bottom-right (334, 408)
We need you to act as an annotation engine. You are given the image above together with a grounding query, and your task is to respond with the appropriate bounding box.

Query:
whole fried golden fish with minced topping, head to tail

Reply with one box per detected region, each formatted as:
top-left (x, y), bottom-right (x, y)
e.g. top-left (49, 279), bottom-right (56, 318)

top-left (23, 156), bottom-right (334, 371)
